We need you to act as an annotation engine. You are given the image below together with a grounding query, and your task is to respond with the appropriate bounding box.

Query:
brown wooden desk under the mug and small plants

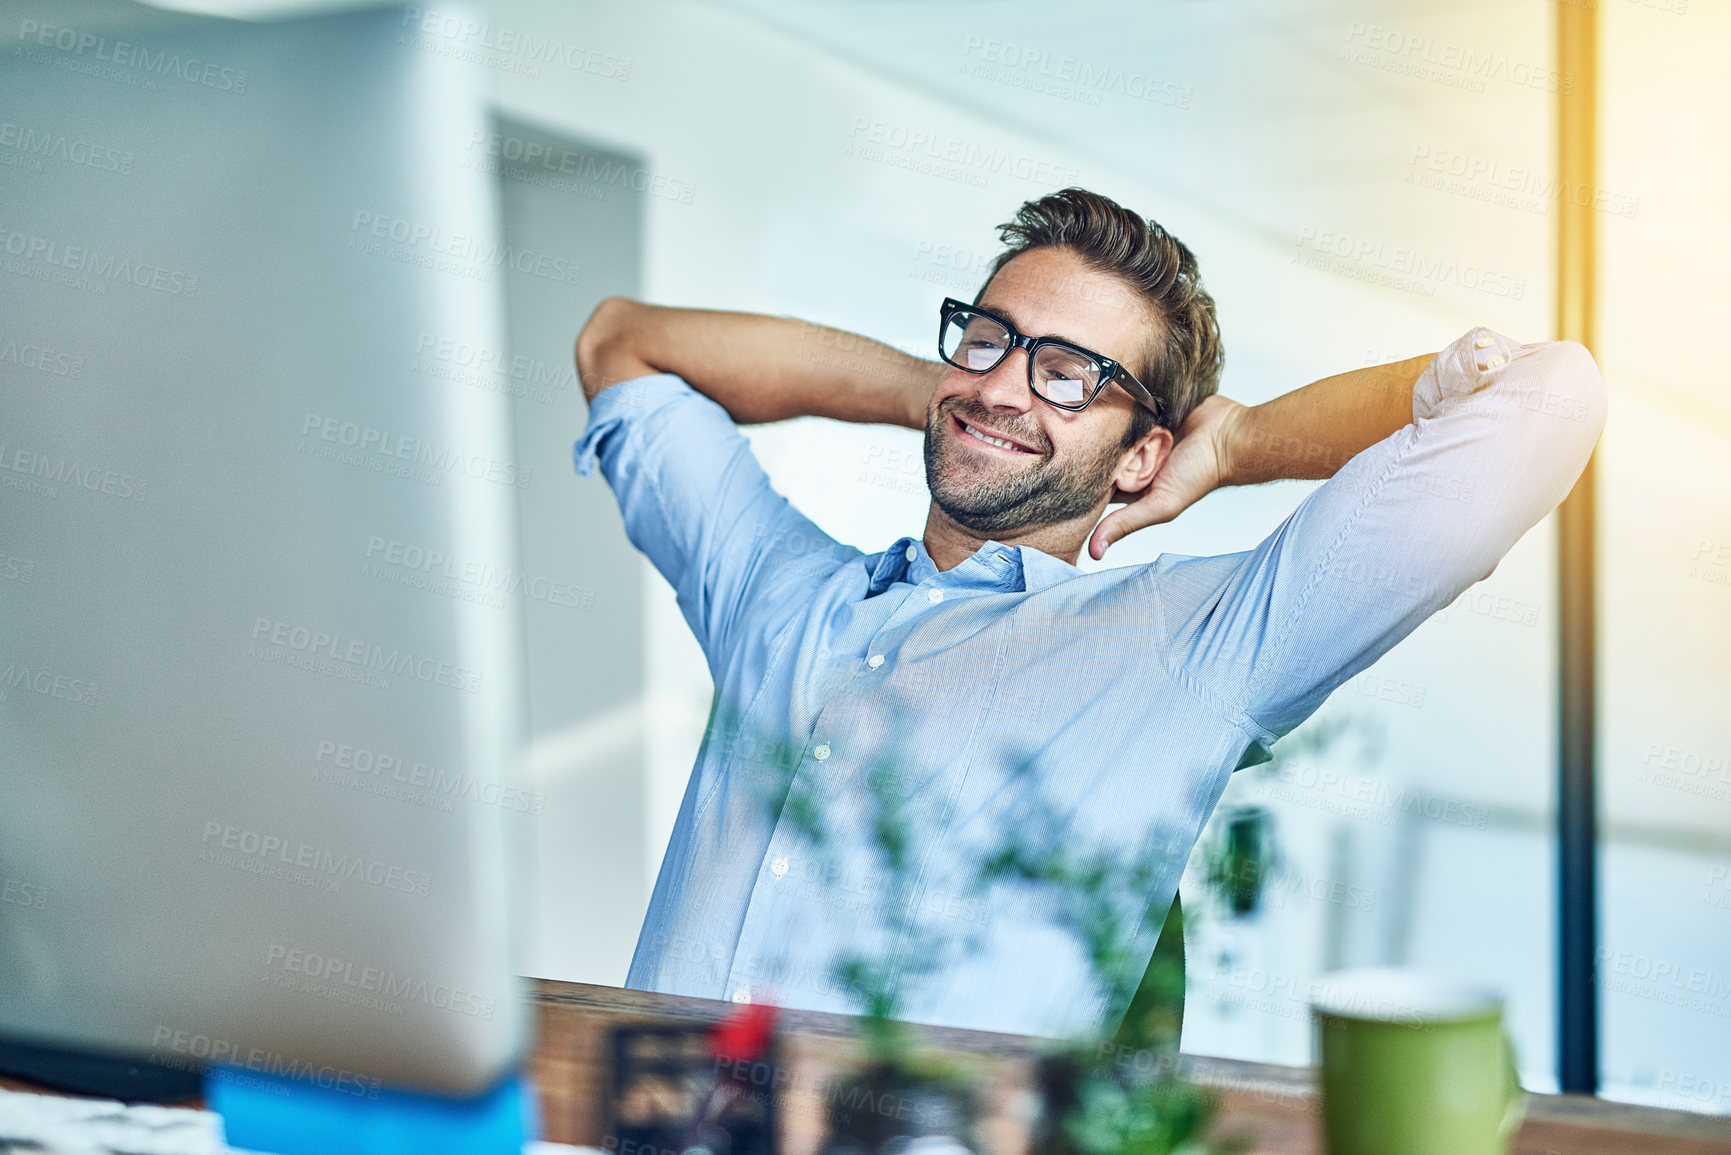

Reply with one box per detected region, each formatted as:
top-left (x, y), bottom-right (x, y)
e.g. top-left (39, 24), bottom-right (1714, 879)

top-left (530, 980), bottom-right (1731, 1155)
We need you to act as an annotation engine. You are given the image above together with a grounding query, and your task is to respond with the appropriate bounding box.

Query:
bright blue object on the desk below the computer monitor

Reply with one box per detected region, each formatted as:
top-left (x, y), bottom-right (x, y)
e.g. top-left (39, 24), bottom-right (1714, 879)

top-left (204, 1067), bottom-right (540, 1155)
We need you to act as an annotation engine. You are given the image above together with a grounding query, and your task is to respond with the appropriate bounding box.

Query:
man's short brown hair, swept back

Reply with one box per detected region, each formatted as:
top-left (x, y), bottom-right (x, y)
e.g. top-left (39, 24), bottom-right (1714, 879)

top-left (975, 189), bottom-right (1226, 448)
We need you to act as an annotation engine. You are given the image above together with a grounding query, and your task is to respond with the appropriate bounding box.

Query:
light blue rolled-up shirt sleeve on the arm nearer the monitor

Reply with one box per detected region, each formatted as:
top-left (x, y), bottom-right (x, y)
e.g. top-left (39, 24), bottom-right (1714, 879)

top-left (573, 372), bottom-right (860, 677)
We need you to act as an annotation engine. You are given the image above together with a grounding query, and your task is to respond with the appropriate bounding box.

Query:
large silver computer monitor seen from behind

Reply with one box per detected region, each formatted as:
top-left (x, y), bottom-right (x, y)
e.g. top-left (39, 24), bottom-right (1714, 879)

top-left (0, 2), bottom-right (533, 1094)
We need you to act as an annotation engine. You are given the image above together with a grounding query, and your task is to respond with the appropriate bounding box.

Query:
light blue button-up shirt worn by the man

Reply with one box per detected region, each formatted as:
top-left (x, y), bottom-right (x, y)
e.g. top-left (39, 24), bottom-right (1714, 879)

top-left (575, 329), bottom-right (1605, 1037)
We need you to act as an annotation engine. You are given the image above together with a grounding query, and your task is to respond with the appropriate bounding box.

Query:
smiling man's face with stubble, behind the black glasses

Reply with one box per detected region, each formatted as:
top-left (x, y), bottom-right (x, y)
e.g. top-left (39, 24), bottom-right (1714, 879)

top-left (926, 248), bottom-right (1151, 537)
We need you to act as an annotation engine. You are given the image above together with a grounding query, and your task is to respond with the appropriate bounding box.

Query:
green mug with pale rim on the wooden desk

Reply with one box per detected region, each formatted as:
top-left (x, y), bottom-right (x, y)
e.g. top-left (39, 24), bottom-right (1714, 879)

top-left (1310, 966), bottom-right (1527, 1155)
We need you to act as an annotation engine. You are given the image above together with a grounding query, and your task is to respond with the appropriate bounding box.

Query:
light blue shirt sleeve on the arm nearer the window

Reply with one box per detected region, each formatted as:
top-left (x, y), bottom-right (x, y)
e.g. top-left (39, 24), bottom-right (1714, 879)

top-left (1149, 327), bottom-right (1606, 767)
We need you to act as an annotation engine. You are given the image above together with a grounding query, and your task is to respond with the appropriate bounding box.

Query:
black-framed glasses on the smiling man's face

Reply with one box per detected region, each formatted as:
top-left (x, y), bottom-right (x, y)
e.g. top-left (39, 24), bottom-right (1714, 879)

top-left (938, 296), bottom-right (1165, 424)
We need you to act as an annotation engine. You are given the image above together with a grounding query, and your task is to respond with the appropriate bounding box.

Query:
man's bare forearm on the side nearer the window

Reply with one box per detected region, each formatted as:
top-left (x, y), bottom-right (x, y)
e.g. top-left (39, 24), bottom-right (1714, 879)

top-left (1222, 353), bottom-right (1437, 485)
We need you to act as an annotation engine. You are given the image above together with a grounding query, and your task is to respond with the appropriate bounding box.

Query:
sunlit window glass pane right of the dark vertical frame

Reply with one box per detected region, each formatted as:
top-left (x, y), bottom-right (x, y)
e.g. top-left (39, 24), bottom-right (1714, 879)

top-left (1594, 0), bottom-right (1731, 1113)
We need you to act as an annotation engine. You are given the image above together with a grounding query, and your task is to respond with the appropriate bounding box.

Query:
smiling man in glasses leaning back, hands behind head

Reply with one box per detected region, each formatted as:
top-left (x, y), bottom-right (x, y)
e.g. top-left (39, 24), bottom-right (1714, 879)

top-left (576, 189), bottom-right (1605, 1037)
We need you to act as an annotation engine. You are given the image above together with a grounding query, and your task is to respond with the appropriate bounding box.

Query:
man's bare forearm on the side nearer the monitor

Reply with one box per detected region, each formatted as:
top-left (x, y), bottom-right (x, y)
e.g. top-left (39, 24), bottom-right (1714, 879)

top-left (576, 298), bottom-right (943, 429)
